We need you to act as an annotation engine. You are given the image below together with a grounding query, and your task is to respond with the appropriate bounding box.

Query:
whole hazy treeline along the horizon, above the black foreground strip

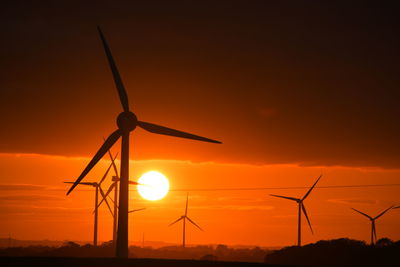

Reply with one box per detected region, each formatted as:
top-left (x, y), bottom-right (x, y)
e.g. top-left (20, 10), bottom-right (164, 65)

top-left (0, 238), bottom-right (400, 267)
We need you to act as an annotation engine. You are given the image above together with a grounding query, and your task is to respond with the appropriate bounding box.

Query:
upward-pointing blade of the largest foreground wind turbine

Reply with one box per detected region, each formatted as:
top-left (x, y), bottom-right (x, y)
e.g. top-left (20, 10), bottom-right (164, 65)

top-left (97, 27), bottom-right (129, 112)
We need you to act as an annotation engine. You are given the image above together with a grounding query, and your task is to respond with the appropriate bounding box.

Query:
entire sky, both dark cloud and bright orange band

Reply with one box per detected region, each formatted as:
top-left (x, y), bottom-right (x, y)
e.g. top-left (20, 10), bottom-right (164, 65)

top-left (0, 0), bottom-right (400, 249)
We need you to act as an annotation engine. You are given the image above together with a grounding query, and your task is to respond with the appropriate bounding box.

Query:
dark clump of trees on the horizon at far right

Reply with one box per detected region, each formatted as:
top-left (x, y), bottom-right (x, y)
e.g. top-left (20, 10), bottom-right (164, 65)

top-left (265, 238), bottom-right (400, 267)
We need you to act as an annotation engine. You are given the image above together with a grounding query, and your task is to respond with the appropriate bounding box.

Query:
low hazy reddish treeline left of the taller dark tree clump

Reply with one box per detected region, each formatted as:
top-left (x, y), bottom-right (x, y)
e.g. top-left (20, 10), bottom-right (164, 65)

top-left (0, 242), bottom-right (271, 262)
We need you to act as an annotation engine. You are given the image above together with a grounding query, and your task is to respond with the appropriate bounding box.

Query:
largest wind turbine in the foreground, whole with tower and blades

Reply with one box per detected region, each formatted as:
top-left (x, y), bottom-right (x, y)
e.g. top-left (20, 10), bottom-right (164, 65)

top-left (67, 27), bottom-right (221, 258)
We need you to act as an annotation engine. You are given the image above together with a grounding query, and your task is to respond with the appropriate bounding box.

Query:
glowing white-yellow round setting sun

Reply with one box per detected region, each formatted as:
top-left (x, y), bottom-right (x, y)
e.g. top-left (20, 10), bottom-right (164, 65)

top-left (138, 171), bottom-right (169, 200)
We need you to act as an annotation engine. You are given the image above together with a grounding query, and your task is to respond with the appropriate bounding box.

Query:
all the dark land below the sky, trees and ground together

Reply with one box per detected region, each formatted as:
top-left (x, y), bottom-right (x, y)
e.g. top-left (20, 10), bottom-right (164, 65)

top-left (0, 241), bottom-right (400, 267)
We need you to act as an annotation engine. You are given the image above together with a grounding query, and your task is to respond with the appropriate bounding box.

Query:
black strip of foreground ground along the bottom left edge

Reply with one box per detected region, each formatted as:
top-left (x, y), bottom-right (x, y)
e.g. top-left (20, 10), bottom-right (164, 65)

top-left (0, 257), bottom-right (294, 267)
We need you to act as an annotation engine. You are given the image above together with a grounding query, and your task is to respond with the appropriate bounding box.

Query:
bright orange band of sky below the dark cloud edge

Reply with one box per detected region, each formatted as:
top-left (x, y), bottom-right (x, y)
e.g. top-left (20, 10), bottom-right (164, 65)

top-left (0, 154), bottom-right (400, 246)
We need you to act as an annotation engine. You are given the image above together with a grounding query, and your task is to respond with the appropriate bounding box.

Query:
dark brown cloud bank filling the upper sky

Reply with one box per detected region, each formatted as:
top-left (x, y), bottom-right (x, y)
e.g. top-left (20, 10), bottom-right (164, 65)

top-left (0, 1), bottom-right (400, 168)
